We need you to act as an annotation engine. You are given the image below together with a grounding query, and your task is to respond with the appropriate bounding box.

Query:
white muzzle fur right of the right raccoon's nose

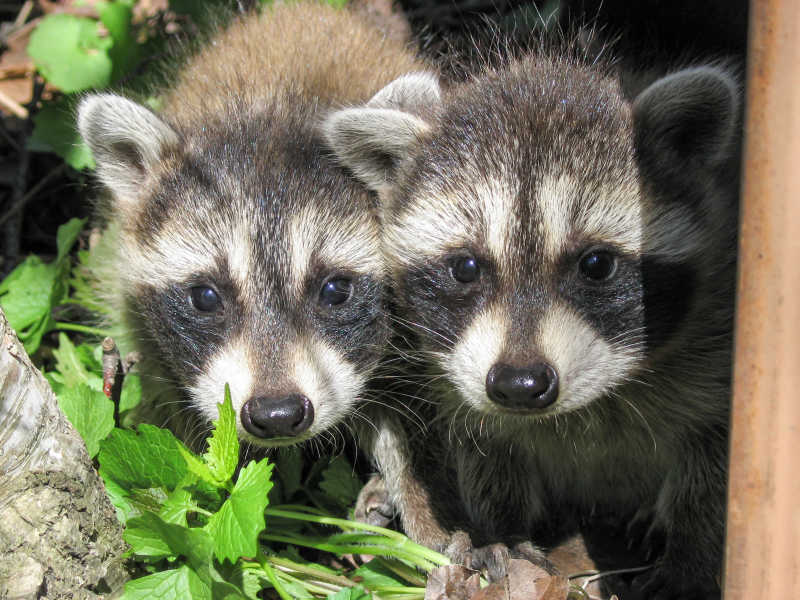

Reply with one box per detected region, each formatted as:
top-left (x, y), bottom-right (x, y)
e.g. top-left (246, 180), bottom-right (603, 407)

top-left (536, 302), bottom-right (637, 413)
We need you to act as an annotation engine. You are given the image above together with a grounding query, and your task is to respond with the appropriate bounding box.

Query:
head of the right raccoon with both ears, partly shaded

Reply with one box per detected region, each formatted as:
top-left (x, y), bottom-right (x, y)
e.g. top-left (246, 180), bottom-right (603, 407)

top-left (324, 63), bottom-right (737, 418)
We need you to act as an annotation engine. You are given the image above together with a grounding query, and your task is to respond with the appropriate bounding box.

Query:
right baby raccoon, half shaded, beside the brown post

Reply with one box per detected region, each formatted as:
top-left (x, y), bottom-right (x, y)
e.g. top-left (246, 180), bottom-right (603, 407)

top-left (324, 53), bottom-right (739, 600)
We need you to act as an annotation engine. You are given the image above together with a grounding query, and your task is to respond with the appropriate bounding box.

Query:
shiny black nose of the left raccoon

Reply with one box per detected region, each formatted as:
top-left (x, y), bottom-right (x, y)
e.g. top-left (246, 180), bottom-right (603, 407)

top-left (240, 394), bottom-right (314, 438)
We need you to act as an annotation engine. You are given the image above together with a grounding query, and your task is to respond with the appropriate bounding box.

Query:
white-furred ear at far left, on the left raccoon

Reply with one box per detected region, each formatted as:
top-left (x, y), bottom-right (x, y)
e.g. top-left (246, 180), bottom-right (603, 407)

top-left (78, 94), bottom-right (178, 203)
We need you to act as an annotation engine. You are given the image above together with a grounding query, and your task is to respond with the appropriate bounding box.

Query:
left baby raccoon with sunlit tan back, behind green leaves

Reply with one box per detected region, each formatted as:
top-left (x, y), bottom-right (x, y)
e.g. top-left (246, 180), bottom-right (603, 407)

top-left (78, 2), bottom-right (428, 446)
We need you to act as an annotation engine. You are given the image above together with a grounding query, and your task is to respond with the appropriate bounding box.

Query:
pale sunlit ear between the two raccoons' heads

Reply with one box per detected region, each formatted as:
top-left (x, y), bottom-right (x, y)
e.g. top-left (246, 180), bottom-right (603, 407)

top-left (322, 73), bottom-right (441, 193)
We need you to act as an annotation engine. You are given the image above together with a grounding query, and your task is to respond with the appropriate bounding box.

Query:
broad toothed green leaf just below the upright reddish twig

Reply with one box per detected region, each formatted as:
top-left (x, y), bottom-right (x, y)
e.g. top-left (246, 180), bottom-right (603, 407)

top-left (99, 424), bottom-right (189, 490)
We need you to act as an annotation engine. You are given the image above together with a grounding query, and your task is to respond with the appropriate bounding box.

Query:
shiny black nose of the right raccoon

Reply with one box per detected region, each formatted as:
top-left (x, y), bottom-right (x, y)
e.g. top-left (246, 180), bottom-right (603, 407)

top-left (486, 363), bottom-right (558, 409)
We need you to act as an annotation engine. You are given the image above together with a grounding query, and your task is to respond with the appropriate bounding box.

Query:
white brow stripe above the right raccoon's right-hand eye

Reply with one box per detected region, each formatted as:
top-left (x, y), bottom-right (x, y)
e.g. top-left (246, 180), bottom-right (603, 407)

top-left (536, 174), bottom-right (642, 261)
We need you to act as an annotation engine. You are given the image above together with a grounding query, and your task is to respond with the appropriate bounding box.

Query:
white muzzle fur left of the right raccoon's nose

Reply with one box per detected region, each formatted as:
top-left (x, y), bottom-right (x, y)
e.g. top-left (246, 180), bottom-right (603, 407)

top-left (442, 306), bottom-right (510, 410)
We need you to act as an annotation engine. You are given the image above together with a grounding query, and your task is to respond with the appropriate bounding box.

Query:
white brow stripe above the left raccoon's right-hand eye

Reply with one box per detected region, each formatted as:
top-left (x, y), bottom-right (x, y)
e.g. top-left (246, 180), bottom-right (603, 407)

top-left (289, 205), bottom-right (384, 295)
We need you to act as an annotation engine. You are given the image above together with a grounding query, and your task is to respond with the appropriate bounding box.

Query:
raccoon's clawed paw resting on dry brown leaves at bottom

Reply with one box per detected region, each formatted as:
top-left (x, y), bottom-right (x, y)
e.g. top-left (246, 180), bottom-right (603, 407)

top-left (444, 531), bottom-right (556, 582)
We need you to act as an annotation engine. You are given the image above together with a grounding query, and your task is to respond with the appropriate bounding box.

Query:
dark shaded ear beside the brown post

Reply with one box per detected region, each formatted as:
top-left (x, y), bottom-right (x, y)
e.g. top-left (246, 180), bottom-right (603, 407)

top-left (633, 66), bottom-right (739, 177)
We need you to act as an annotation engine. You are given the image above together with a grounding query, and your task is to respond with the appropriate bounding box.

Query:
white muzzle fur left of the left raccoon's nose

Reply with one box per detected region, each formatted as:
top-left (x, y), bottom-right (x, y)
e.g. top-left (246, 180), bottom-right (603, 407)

top-left (189, 341), bottom-right (255, 428)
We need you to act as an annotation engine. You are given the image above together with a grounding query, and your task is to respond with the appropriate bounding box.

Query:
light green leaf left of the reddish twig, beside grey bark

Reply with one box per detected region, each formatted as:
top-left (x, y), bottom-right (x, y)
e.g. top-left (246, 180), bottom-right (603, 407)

top-left (58, 383), bottom-right (114, 458)
